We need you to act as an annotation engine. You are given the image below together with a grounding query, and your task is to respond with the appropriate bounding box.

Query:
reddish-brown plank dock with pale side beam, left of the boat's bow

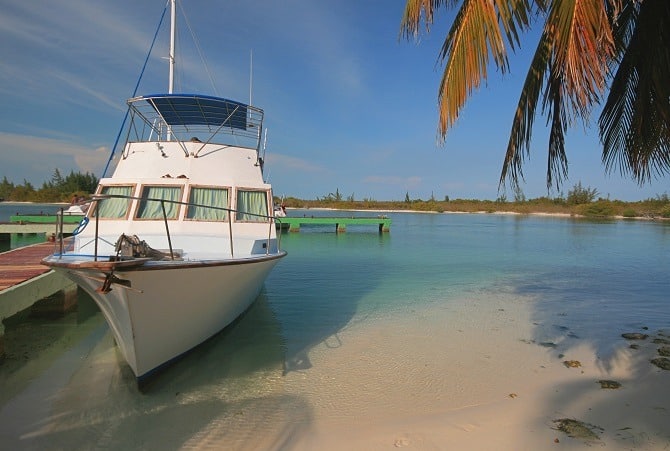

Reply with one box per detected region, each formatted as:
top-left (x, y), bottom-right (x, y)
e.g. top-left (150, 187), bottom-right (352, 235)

top-left (0, 242), bottom-right (77, 354)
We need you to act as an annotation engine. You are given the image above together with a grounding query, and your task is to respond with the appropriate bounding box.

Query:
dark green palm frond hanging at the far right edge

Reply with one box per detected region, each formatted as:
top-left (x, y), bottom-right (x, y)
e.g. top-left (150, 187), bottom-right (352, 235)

top-left (599, 1), bottom-right (670, 184)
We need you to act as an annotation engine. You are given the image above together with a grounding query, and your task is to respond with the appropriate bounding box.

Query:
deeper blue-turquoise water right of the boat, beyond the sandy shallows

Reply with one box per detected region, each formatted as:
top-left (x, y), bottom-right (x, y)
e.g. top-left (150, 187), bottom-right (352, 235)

top-left (274, 213), bottom-right (670, 372)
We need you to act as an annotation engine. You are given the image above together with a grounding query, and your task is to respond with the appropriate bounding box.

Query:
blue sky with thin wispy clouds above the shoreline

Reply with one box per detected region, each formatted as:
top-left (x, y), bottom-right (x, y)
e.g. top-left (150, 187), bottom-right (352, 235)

top-left (0, 0), bottom-right (670, 201)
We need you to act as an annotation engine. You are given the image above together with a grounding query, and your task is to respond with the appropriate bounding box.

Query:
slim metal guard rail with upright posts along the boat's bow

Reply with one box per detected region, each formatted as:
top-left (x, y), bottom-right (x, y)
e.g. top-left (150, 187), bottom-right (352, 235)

top-left (56, 194), bottom-right (281, 261)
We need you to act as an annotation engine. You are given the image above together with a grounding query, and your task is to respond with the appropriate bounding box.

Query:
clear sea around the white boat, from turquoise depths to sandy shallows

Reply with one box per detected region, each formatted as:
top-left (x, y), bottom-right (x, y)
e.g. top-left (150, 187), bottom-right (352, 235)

top-left (0, 204), bottom-right (670, 450)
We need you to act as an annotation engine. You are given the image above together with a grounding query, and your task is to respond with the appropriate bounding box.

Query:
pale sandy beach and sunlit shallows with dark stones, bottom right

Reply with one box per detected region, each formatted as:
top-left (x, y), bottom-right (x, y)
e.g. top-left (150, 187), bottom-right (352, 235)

top-left (276, 299), bottom-right (670, 450)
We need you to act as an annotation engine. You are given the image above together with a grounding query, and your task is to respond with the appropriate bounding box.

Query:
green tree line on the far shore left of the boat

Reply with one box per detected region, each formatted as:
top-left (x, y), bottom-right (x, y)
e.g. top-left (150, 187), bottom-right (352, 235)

top-left (0, 169), bottom-right (98, 202)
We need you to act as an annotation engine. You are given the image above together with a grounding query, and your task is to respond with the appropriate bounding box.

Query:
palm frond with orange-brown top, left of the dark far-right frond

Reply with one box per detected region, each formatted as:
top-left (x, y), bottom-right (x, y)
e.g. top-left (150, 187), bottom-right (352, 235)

top-left (500, 0), bottom-right (614, 188)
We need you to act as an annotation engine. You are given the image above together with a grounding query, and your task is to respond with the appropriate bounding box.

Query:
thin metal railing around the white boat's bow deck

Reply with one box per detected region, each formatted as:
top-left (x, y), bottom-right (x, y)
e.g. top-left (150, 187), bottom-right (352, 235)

top-left (57, 194), bottom-right (281, 261)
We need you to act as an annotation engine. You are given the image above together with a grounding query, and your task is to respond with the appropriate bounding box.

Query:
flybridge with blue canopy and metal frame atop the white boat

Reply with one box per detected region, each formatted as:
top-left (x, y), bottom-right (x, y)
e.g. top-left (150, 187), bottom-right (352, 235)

top-left (128, 94), bottom-right (263, 149)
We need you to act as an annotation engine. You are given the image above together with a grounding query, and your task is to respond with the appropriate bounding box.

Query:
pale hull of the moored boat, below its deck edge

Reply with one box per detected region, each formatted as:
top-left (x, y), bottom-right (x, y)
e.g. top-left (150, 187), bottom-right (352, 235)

top-left (52, 252), bottom-right (285, 380)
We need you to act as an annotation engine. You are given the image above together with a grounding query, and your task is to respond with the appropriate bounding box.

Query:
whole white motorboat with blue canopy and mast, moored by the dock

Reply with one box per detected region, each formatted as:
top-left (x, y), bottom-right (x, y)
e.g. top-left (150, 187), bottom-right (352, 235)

top-left (42, 0), bottom-right (286, 381)
